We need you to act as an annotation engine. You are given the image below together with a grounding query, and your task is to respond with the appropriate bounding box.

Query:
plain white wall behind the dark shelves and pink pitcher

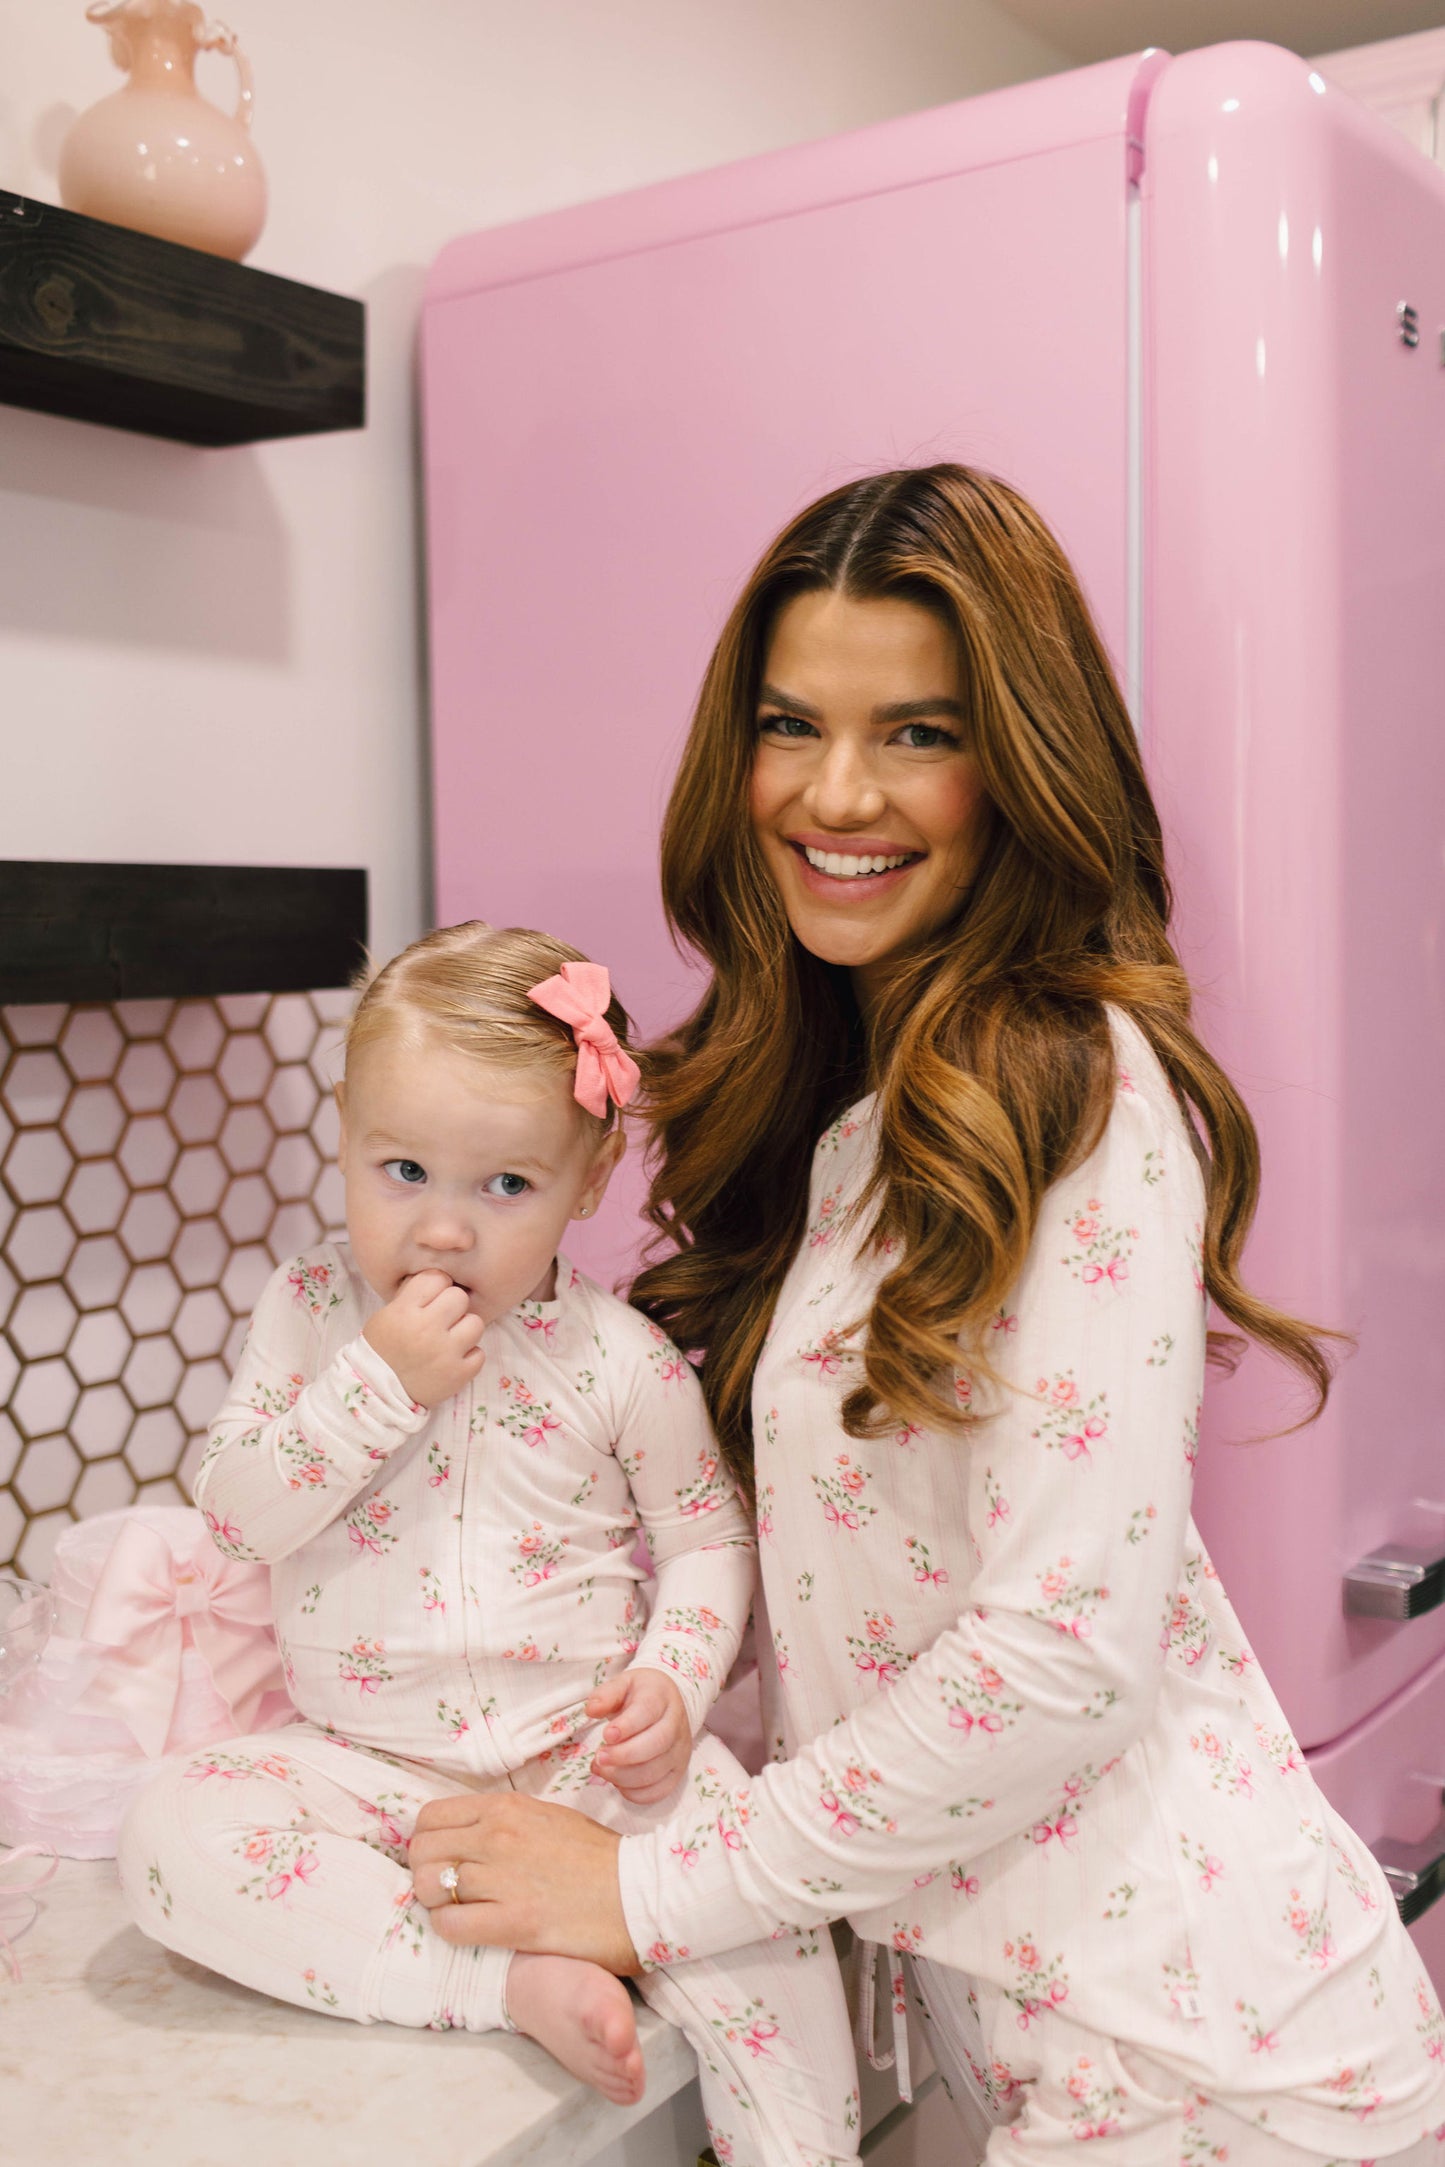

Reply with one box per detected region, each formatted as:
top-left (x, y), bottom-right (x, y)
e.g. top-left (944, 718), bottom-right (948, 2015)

top-left (0, 0), bottom-right (1064, 953)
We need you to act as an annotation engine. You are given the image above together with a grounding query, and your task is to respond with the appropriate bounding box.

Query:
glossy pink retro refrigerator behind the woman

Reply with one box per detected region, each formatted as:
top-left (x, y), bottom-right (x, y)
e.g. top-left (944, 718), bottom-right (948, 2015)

top-left (425, 46), bottom-right (1445, 1985)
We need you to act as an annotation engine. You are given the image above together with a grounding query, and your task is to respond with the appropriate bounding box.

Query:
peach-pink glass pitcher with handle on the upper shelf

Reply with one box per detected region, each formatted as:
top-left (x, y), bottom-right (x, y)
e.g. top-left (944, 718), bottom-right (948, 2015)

top-left (61, 0), bottom-right (266, 260)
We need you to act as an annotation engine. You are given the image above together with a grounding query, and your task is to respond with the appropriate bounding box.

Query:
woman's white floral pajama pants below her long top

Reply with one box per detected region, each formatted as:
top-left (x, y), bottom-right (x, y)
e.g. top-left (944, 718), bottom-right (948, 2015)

top-left (903, 1957), bottom-right (1445, 2167)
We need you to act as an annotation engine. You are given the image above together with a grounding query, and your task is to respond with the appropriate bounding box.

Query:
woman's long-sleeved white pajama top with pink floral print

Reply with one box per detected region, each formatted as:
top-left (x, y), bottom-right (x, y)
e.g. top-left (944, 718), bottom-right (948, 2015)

top-left (622, 1014), bottom-right (1445, 2156)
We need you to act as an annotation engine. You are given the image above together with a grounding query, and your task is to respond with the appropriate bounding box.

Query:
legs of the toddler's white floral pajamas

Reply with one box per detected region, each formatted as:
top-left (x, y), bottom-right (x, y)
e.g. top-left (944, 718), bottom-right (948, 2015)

top-left (117, 1723), bottom-right (858, 2167)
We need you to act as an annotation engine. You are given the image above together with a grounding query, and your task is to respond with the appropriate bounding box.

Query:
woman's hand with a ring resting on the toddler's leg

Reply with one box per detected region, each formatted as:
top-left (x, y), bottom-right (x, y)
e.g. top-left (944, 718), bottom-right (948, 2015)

top-left (412, 1792), bottom-right (641, 1978)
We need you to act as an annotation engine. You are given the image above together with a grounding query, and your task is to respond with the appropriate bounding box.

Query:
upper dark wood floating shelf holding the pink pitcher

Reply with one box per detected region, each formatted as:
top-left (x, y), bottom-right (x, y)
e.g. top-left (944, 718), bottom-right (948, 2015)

top-left (0, 195), bottom-right (366, 444)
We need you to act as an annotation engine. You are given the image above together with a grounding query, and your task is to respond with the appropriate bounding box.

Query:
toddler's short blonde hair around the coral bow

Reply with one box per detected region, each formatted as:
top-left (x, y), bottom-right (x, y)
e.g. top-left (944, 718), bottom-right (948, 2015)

top-left (344, 919), bottom-right (630, 1136)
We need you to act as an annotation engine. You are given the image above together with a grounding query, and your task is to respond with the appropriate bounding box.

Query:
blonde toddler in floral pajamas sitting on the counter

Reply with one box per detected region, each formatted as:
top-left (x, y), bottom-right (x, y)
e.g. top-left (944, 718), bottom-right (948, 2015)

top-left (119, 923), bottom-right (858, 2167)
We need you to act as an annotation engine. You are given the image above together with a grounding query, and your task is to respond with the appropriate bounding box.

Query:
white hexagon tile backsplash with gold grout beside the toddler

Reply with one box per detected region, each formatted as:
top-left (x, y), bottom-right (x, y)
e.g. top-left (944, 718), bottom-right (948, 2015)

top-left (0, 992), bottom-right (351, 1580)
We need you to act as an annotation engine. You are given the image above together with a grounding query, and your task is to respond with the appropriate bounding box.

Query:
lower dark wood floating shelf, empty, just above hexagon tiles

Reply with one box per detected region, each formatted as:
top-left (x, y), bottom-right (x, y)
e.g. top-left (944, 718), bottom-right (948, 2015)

top-left (0, 858), bottom-right (366, 1003)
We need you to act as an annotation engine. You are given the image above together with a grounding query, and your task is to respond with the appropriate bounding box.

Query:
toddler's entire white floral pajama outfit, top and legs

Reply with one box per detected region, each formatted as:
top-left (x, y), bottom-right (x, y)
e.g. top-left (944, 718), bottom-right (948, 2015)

top-left (119, 1244), bottom-right (858, 2167)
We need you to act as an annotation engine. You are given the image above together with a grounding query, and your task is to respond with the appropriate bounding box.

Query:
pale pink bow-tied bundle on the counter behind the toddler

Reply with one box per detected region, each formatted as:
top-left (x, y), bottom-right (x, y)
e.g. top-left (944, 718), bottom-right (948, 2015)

top-left (0, 1506), bottom-right (295, 1859)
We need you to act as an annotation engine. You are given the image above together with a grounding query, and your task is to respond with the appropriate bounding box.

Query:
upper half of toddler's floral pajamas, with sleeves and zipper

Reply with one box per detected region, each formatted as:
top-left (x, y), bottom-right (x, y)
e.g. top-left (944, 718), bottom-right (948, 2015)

top-left (195, 1244), bottom-right (756, 1794)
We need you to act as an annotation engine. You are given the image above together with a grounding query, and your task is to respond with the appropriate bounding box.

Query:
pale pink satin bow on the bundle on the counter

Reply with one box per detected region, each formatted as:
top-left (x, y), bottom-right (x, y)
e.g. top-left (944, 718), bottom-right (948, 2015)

top-left (82, 1519), bottom-right (284, 1760)
